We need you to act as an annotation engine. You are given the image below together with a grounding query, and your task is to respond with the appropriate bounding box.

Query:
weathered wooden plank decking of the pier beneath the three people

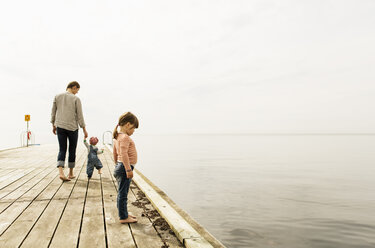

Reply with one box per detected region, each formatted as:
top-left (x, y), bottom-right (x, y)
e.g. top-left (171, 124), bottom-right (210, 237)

top-left (0, 145), bottom-right (183, 248)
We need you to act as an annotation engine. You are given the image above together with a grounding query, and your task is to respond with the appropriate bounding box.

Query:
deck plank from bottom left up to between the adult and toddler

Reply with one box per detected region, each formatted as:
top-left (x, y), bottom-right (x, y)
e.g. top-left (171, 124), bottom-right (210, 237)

top-left (21, 156), bottom-right (85, 247)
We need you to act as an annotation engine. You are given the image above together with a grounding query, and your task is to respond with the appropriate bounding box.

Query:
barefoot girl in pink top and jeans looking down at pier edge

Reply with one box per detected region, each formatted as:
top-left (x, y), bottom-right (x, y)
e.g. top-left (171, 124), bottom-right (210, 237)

top-left (113, 112), bottom-right (138, 224)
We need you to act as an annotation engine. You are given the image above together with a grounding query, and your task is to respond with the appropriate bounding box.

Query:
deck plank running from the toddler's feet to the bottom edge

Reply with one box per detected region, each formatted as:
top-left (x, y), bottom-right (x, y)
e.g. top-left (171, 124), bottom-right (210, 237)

top-left (79, 164), bottom-right (106, 248)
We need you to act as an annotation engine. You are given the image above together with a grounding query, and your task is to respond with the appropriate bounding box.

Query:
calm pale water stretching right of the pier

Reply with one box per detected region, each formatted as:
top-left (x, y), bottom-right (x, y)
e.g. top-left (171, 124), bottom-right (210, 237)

top-left (134, 135), bottom-right (375, 248)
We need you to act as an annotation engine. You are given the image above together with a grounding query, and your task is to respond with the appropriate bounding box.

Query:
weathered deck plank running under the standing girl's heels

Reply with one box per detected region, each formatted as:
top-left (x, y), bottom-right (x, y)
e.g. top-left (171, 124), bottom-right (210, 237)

top-left (101, 153), bottom-right (136, 248)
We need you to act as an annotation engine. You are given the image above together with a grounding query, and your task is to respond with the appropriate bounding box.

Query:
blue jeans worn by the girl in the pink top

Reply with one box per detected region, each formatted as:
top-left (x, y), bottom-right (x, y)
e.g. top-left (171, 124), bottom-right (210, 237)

top-left (113, 162), bottom-right (134, 220)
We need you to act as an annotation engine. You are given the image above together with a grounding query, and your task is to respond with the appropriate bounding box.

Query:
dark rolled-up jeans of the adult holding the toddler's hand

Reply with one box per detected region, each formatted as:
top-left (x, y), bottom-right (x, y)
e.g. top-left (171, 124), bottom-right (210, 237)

top-left (56, 127), bottom-right (78, 168)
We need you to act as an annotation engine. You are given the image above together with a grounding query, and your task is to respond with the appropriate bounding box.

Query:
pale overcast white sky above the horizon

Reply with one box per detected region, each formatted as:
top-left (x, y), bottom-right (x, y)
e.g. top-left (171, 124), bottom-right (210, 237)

top-left (0, 0), bottom-right (375, 148)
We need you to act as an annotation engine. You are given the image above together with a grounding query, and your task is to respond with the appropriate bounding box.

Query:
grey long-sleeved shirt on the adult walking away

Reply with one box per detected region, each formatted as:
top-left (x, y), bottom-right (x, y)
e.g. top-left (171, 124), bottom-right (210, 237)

top-left (51, 91), bottom-right (86, 131)
